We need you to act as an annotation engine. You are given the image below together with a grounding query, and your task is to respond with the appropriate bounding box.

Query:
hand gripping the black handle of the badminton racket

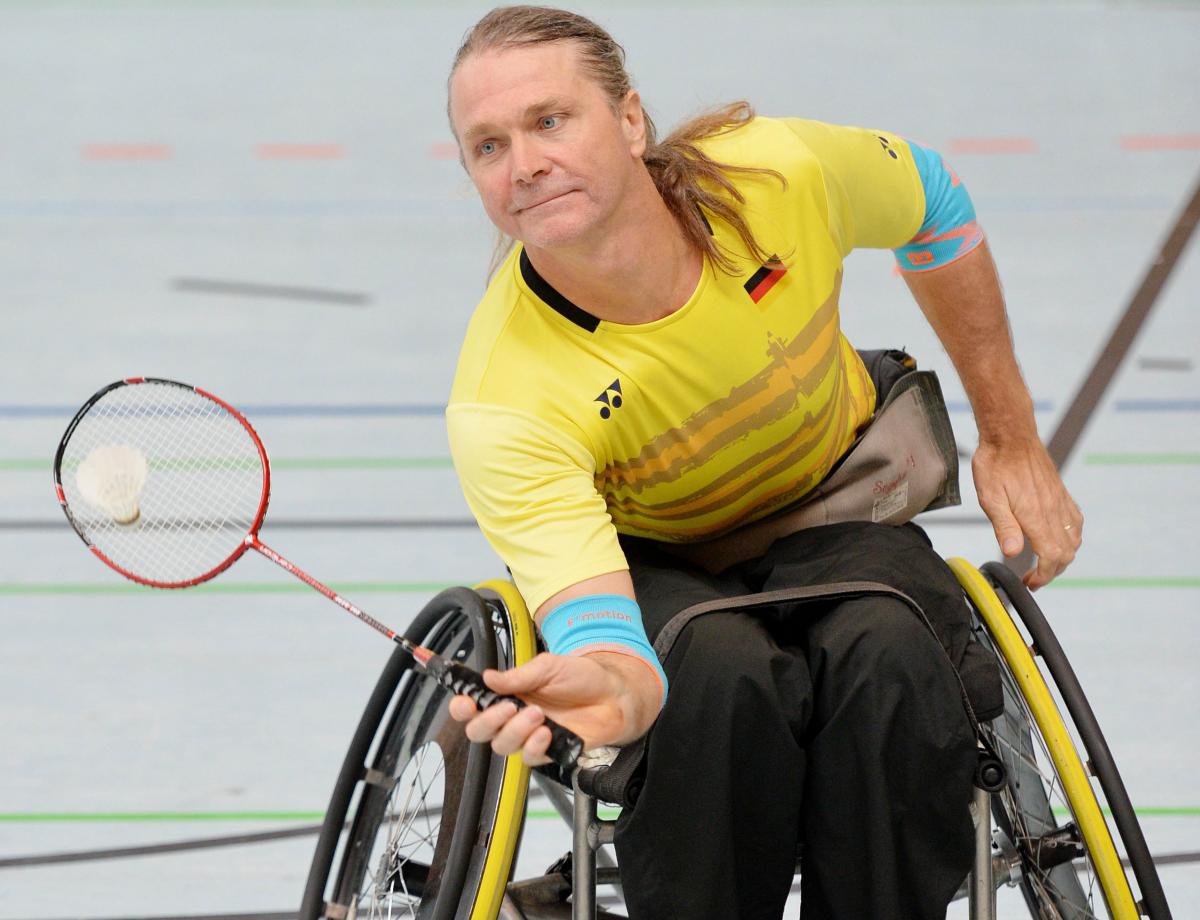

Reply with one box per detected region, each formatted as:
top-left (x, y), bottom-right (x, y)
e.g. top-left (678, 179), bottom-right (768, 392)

top-left (450, 653), bottom-right (661, 766)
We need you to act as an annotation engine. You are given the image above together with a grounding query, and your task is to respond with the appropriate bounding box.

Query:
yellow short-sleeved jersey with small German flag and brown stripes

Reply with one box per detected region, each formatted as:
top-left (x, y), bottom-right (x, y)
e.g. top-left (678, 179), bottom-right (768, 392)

top-left (446, 118), bottom-right (925, 609)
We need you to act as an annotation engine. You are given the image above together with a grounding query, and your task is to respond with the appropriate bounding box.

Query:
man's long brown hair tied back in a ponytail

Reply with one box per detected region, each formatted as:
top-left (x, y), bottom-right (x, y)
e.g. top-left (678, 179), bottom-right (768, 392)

top-left (446, 6), bottom-right (787, 275)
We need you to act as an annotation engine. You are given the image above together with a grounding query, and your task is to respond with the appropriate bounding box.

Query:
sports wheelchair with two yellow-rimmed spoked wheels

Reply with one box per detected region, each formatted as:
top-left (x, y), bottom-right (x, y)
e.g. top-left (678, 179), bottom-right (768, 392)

top-left (299, 559), bottom-right (1170, 920)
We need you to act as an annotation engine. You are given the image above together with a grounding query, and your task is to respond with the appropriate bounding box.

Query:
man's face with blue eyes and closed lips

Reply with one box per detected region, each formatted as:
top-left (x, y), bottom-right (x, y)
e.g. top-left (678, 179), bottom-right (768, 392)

top-left (450, 42), bottom-right (644, 248)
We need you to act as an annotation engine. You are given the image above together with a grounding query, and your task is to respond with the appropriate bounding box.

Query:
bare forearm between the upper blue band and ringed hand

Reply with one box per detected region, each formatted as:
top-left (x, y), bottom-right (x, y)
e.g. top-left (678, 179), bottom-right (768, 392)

top-left (904, 241), bottom-right (1038, 443)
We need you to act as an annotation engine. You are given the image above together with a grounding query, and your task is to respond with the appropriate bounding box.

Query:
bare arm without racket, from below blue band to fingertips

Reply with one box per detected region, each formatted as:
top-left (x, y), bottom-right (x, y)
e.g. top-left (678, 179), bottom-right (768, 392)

top-left (902, 242), bottom-right (1084, 589)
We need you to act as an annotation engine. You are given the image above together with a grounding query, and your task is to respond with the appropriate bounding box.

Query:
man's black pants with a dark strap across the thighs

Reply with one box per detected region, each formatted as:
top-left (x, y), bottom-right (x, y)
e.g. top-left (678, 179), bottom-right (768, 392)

top-left (616, 524), bottom-right (976, 920)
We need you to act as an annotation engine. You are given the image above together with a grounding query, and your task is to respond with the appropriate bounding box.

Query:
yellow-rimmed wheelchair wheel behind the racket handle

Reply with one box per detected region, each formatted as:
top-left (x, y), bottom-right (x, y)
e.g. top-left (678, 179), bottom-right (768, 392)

top-left (300, 589), bottom-right (537, 920)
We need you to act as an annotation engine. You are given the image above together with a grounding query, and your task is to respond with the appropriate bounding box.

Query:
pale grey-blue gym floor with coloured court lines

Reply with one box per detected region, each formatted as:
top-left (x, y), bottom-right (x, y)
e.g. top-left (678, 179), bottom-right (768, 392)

top-left (0, 0), bottom-right (1200, 920)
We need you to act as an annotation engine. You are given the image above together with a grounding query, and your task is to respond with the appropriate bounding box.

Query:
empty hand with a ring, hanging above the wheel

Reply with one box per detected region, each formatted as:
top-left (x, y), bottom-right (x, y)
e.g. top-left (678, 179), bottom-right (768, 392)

top-left (971, 439), bottom-right (1084, 590)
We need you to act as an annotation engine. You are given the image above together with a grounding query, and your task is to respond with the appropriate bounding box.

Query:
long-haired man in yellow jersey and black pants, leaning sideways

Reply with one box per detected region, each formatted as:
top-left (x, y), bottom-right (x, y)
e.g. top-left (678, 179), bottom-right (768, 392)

top-left (448, 7), bottom-right (1082, 920)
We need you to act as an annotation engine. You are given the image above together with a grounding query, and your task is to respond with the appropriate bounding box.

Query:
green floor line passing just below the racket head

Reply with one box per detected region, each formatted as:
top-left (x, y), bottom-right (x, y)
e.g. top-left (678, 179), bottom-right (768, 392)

top-left (0, 575), bottom-right (1200, 597)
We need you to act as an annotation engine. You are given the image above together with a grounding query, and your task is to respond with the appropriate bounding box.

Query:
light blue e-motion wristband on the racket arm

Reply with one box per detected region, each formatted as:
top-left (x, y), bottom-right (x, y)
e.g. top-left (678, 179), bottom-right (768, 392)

top-left (541, 594), bottom-right (667, 702)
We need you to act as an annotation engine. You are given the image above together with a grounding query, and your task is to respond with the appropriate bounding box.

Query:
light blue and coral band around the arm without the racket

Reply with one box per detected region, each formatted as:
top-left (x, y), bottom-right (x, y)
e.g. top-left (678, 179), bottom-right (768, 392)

top-left (893, 140), bottom-right (983, 271)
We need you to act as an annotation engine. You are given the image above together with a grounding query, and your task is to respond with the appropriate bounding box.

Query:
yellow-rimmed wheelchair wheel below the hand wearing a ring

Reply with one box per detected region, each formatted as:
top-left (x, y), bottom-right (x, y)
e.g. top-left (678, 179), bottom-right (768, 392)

top-left (949, 559), bottom-right (1156, 920)
